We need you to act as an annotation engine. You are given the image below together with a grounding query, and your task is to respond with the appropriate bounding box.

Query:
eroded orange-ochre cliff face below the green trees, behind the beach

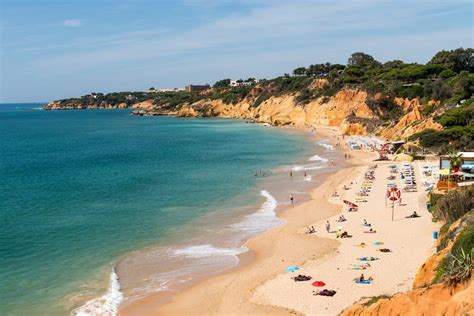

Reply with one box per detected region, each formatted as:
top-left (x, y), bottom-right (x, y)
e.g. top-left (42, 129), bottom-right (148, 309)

top-left (45, 87), bottom-right (442, 140)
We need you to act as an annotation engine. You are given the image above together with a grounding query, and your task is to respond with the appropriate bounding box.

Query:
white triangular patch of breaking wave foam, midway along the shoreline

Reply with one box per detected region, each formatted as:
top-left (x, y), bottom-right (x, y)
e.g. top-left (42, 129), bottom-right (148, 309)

top-left (232, 190), bottom-right (283, 233)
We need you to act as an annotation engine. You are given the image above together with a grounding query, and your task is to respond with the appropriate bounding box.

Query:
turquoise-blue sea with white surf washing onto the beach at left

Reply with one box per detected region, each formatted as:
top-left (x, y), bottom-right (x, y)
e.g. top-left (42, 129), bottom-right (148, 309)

top-left (0, 104), bottom-right (338, 315)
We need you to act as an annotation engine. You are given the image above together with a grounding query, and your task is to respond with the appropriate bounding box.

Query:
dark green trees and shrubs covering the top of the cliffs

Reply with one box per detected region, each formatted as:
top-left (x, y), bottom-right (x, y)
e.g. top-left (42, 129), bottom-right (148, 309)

top-left (46, 48), bottom-right (474, 152)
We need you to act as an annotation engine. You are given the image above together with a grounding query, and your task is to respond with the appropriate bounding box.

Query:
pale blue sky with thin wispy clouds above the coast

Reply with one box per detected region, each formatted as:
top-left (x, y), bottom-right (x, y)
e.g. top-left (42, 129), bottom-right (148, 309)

top-left (0, 0), bottom-right (474, 103)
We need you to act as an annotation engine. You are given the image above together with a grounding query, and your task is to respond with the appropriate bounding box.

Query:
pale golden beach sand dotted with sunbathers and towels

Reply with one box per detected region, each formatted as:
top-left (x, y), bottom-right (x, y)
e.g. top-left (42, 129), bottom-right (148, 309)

top-left (119, 128), bottom-right (438, 315)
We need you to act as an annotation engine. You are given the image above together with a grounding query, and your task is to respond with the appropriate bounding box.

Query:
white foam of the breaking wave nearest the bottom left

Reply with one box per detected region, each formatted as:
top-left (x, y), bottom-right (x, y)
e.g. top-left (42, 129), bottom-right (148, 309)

top-left (72, 269), bottom-right (123, 316)
